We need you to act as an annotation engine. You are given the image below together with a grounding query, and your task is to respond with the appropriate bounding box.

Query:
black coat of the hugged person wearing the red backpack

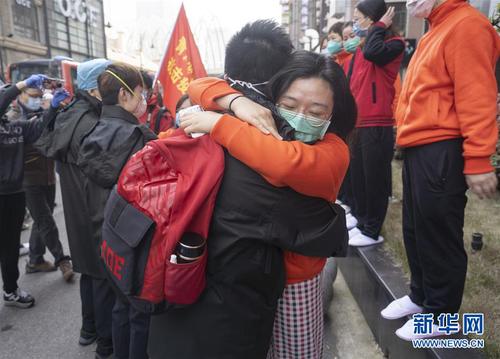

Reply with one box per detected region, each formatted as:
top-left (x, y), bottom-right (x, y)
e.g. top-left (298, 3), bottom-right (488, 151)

top-left (148, 153), bottom-right (347, 359)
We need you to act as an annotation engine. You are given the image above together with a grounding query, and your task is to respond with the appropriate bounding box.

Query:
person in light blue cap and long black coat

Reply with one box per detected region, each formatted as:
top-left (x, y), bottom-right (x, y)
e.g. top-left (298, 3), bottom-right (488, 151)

top-left (38, 59), bottom-right (115, 358)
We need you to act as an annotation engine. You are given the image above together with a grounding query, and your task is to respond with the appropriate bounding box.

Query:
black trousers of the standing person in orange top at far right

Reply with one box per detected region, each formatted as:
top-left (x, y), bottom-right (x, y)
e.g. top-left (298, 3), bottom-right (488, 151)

top-left (403, 139), bottom-right (467, 319)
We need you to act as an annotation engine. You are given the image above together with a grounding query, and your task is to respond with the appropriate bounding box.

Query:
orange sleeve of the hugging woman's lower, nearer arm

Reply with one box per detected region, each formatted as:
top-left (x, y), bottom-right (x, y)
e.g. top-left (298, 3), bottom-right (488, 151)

top-left (211, 114), bottom-right (349, 202)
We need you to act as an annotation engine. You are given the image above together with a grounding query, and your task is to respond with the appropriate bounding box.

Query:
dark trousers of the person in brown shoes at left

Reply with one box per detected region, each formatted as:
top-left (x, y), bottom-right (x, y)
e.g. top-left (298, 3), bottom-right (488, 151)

top-left (25, 185), bottom-right (69, 266)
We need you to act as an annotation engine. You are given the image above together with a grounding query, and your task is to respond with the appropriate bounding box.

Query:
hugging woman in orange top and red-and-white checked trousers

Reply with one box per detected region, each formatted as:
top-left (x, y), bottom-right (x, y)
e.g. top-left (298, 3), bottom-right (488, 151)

top-left (176, 52), bottom-right (355, 358)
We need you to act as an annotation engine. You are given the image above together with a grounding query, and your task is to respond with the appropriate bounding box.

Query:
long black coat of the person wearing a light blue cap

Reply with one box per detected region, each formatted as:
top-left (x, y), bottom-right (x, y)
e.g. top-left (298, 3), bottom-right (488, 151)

top-left (35, 91), bottom-right (104, 278)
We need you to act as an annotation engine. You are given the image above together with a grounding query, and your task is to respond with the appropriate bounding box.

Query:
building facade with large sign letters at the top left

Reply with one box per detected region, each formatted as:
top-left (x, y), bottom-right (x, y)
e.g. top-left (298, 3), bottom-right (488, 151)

top-left (0, 0), bottom-right (106, 77)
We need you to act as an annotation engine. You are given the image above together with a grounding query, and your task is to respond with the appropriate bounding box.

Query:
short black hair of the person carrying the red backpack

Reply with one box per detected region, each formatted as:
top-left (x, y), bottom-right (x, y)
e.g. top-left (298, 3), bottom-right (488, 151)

top-left (224, 20), bottom-right (293, 83)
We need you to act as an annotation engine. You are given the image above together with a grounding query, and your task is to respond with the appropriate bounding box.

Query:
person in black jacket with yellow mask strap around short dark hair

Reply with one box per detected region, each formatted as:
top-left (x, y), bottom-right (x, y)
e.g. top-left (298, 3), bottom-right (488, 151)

top-left (77, 63), bottom-right (156, 359)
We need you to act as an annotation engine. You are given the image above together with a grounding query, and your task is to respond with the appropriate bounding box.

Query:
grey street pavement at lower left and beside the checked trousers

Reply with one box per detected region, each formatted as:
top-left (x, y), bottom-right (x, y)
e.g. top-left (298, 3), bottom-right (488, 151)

top-left (0, 184), bottom-right (383, 359)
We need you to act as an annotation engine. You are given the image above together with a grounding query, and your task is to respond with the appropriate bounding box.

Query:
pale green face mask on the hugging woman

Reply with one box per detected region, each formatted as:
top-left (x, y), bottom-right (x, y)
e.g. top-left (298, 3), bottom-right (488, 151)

top-left (278, 107), bottom-right (331, 143)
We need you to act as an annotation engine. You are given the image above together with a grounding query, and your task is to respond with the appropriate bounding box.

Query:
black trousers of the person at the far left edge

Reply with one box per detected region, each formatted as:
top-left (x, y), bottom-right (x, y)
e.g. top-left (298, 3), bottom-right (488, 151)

top-left (0, 192), bottom-right (26, 293)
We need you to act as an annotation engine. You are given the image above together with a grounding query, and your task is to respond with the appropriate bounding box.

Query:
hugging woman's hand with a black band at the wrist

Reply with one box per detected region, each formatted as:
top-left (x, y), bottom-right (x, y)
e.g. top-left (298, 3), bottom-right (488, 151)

top-left (231, 97), bottom-right (283, 140)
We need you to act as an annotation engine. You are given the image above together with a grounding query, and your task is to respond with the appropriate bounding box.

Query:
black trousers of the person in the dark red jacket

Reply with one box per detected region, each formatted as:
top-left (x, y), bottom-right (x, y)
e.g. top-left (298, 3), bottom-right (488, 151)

top-left (350, 127), bottom-right (394, 239)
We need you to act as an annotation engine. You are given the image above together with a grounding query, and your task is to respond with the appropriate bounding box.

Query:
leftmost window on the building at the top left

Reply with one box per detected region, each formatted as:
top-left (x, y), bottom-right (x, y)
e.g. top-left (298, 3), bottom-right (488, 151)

top-left (12, 0), bottom-right (40, 41)
